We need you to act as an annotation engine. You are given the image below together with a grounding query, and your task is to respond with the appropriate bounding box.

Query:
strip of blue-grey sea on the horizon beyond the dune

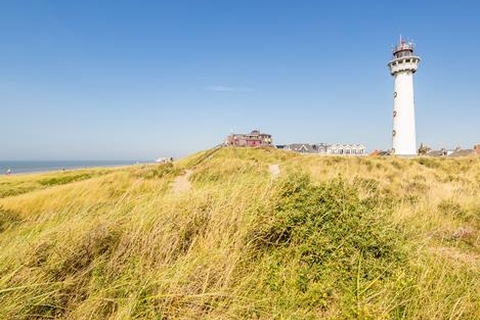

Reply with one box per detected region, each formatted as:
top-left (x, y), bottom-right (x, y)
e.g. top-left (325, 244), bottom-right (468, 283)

top-left (0, 160), bottom-right (154, 174)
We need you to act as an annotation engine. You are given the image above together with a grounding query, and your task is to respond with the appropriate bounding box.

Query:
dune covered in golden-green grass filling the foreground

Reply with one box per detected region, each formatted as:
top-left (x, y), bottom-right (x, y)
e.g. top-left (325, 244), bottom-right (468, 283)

top-left (0, 148), bottom-right (480, 319)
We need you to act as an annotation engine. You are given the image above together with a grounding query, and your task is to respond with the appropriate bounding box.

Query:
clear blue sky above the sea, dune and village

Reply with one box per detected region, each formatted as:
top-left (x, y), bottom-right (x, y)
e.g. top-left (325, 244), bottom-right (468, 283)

top-left (0, 0), bottom-right (480, 160)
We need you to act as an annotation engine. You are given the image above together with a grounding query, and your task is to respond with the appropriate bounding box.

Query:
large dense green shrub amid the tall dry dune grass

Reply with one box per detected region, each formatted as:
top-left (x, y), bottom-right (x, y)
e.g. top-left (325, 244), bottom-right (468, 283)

top-left (249, 175), bottom-right (406, 316)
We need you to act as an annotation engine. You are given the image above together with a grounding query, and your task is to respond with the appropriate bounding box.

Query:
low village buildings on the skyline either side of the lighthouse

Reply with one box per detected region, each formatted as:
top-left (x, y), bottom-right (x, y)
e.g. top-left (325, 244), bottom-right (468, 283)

top-left (222, 130), bottom-right (480, 157)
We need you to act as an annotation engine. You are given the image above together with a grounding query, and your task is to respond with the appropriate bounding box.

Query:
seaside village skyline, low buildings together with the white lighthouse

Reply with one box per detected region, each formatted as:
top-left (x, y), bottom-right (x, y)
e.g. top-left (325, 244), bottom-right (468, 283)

top-left (223, 37), bottom-right (480, 157)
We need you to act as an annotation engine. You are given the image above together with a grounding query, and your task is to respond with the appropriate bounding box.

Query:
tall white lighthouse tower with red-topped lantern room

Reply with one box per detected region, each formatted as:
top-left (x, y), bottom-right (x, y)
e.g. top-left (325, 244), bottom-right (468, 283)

top-left (388, 37), bottom-right (420, 156)
